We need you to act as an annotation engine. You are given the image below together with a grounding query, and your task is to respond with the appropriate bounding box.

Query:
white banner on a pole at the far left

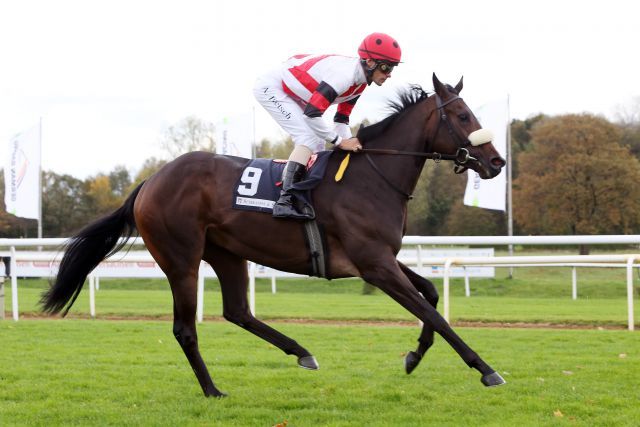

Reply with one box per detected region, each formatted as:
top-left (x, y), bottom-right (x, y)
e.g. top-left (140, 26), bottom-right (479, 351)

top-left (4, 125), bottom-right (40, 219)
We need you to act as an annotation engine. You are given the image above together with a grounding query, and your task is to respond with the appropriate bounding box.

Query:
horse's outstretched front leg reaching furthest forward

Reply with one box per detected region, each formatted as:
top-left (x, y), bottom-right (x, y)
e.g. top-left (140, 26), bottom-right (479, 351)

top-left (359, 259), bottom-right (505, 386)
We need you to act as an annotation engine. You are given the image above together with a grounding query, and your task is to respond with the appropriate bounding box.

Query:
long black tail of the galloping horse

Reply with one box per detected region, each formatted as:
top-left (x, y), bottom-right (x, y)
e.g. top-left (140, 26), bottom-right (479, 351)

top-left (40, 182), bottom-right (144, 316)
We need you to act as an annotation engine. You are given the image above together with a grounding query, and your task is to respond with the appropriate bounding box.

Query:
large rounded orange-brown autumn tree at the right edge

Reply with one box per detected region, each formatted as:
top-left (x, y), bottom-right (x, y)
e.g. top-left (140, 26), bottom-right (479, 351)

top-left (513, 114), bottom-right (640, 239)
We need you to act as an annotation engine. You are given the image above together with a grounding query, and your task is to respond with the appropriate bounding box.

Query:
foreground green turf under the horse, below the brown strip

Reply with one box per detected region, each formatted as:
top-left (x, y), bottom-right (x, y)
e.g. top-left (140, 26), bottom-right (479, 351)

top-left (0, 319), bottom-right (640, 426)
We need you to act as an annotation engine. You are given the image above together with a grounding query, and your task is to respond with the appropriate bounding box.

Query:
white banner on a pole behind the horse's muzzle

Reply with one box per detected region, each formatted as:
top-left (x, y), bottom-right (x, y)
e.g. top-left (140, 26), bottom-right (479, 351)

top-left (464, 98), bottom-right (509, 211)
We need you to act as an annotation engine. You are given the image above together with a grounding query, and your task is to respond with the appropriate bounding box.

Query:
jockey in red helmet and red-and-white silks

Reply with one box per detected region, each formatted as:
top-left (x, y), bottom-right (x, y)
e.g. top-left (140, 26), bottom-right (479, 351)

top-left (253, 33), bottom-right (401, 219)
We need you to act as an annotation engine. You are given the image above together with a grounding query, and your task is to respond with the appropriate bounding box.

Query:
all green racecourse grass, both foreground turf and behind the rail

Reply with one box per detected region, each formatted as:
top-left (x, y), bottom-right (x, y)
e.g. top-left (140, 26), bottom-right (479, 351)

top-left (0, 262), bottom-right (640, 426)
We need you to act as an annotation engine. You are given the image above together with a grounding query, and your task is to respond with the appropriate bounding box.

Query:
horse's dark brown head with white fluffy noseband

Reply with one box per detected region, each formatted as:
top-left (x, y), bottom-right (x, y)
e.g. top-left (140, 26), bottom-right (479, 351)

top-left (428, 73), bottom-right (506, 179)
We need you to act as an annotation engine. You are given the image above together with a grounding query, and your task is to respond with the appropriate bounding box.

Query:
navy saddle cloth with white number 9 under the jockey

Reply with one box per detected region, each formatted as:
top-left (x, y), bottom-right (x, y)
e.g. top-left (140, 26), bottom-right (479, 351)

top-left (233, 151), bottom-right (332, 213)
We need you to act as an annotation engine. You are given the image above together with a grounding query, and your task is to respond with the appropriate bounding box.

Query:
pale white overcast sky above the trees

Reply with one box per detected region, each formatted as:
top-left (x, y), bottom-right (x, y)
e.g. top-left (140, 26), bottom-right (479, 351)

top-left (0, 0), bottom-right (640, 179)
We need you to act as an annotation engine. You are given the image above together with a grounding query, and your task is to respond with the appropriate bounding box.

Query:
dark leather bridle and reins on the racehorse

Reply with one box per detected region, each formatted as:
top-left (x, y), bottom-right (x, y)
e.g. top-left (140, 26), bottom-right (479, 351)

top-left (357, 93), bottom-right (478, 200)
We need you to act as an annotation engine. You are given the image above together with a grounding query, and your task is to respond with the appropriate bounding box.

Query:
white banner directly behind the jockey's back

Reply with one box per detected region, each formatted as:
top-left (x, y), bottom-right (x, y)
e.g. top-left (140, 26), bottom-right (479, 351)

top-left (216, 113), bottom-right (253, 159)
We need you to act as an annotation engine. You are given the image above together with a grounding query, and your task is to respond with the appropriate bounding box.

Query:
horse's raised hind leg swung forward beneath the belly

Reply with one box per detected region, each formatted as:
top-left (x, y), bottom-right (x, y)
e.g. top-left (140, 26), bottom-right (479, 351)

top-left (204, 247), bottom-right (318, 369)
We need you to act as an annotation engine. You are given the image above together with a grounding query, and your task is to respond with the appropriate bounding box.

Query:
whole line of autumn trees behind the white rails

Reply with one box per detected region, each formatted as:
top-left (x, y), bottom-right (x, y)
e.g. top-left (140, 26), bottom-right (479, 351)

top-left (0, 104), bottom-right (640, 237)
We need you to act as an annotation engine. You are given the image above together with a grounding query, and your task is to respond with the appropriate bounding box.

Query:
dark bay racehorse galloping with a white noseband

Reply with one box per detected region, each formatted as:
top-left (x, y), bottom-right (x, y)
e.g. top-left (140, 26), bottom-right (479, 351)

top-left (41, 74), bottom-right (505, 396)
